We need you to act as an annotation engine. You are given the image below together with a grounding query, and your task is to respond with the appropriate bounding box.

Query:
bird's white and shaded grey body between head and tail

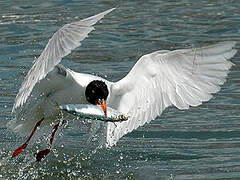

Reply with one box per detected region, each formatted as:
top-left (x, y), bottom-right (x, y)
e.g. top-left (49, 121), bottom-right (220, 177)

top-left (8, 65), bottom-right (110, 134)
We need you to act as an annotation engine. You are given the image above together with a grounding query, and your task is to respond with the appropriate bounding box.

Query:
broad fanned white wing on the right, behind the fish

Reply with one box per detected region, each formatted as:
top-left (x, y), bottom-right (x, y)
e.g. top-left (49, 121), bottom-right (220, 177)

top-left (106, 42), bottom-right (237, 146)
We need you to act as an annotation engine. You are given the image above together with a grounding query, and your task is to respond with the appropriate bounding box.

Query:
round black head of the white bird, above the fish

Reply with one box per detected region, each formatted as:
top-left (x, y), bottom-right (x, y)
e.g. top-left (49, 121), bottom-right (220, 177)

top-left (85, 80), bottom-right (109, 105)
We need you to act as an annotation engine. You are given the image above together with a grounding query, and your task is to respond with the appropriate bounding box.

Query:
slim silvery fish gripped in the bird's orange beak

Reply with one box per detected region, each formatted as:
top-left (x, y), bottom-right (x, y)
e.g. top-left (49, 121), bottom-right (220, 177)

top-left (59, 104), bottom-right (129, 122)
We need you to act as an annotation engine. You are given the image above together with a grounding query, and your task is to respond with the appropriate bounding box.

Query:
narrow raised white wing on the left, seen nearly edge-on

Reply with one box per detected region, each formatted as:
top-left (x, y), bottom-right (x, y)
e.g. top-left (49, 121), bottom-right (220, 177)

top-left (12, 8), bottom-right (115, 112)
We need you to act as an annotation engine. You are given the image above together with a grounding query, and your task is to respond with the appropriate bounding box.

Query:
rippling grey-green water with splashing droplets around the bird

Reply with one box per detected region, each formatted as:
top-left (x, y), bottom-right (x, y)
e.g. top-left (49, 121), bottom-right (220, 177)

top-left (0, 0), bottom-right (240, 179)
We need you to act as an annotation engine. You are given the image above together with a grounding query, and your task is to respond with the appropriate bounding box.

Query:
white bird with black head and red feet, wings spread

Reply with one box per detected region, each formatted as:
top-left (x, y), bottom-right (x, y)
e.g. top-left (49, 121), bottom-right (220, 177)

top-left (8, 8), bottom-right (237, 159)
